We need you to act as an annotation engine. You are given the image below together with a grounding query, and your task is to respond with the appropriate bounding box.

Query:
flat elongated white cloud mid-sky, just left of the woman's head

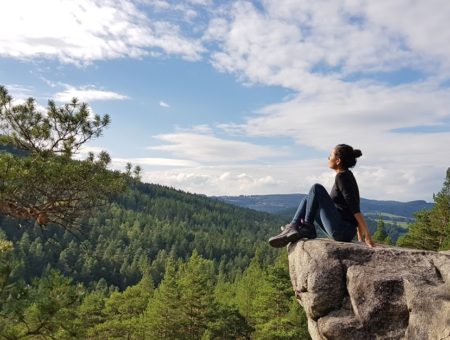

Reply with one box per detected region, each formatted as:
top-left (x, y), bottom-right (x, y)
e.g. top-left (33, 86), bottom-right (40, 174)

top-left (148, 131), bottom-right (286, 164)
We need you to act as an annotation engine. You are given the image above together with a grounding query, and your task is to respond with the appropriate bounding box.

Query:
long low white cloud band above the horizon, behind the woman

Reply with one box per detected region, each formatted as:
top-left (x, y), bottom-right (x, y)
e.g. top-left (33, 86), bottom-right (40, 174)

top-left (142, 159), bottom-right (445, 201)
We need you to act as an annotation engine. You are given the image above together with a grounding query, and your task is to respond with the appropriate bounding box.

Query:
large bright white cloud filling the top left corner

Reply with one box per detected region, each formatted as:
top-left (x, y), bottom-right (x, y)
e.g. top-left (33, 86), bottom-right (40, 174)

top-left (0, 0), bottom-right (203, 64)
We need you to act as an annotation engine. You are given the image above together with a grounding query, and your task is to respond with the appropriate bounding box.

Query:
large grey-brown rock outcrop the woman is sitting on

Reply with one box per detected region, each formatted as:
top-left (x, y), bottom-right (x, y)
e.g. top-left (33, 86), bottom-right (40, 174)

top-left (288, 239), bottom-right (450, 340)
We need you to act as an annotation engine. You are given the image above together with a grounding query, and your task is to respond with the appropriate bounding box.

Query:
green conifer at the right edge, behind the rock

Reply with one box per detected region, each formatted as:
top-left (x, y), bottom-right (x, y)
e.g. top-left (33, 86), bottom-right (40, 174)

top-left (397, 168), bottom-right (450, 251)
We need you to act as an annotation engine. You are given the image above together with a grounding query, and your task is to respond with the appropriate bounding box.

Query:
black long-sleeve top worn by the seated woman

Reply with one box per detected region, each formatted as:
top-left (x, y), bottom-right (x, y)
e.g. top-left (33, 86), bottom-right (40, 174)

top-left (330, 170), bottom-right (361, 226)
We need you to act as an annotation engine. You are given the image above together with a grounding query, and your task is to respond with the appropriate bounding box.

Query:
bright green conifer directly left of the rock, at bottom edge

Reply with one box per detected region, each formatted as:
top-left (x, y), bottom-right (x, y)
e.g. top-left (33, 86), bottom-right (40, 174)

top-left (216, 253), bottom-right (309, 339)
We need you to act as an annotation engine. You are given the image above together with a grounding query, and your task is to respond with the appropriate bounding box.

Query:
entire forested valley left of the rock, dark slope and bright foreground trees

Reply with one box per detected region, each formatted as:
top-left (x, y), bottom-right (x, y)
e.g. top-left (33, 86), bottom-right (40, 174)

top-left (0, 179), bottom-right (308, 339)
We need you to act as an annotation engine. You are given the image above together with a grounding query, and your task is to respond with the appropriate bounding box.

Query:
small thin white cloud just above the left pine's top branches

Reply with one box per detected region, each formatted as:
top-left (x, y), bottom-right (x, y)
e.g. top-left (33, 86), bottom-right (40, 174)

top-left (53, 85), bottom-right (129, 103)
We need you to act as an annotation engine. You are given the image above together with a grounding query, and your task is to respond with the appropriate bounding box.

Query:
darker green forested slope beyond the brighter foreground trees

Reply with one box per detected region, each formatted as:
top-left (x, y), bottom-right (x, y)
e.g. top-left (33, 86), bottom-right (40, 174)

top-left (1, 181), bottom-right (282, 289)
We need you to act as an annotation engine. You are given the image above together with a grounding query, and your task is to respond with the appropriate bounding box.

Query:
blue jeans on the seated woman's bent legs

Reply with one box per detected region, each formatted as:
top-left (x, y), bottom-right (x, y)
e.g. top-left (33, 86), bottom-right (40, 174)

top-left (291, 184), bottom-right (356, 242)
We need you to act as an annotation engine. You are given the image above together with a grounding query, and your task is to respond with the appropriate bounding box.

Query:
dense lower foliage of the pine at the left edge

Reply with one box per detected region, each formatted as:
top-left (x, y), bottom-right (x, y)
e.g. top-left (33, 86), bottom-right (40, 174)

top-left (0, 153), bottom-right (123, 228)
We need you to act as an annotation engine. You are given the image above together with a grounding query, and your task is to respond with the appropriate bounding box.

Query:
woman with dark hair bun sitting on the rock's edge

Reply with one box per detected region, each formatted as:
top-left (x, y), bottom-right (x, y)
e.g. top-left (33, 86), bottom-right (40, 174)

top-left (269, 144), bottom-right (375, 248)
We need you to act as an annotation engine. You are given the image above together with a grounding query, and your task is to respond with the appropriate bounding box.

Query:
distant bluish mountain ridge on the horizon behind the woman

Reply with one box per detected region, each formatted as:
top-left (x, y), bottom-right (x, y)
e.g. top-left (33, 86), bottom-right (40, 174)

top-left (214, 194), bottom-right (434, 218)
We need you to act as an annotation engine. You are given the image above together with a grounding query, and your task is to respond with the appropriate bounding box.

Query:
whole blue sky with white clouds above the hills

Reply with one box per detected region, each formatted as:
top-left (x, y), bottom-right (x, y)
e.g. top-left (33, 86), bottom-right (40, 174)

top-left (0, 0), bottom-right (450, 201)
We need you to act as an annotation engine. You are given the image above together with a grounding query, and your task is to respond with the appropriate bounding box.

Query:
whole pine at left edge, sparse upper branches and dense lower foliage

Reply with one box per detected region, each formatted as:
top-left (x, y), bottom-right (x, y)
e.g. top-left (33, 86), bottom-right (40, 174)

top-left (0, 86), bottom-right (124, 231)
